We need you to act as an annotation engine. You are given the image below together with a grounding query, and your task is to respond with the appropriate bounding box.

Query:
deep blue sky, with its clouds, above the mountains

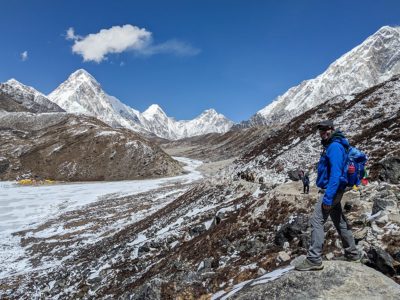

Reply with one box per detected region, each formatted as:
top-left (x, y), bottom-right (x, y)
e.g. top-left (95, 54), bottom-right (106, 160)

top-left (0, 0), bottom-right (400, 122)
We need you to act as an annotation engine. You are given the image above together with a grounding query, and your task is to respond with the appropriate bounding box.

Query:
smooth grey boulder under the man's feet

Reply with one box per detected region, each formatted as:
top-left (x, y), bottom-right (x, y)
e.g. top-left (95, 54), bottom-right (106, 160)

top-left (228, 261), bottom-right (400, 300)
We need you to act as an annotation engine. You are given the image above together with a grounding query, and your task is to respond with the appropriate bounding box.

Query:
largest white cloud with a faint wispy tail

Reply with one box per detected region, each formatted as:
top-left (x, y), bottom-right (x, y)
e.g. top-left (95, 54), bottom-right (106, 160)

top-left (66, 24), bottom-right (200, 63)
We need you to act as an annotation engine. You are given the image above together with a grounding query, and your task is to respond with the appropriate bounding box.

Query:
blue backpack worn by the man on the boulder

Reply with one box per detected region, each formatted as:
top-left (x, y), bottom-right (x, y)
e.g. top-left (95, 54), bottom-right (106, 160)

top-left (340, 146), bottom-right (368, 188)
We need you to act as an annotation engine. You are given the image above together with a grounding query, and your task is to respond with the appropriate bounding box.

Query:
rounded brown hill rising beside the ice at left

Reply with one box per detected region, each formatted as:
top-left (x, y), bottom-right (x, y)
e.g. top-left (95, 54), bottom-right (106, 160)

top-left (0, 113), bottom-right (182, 181)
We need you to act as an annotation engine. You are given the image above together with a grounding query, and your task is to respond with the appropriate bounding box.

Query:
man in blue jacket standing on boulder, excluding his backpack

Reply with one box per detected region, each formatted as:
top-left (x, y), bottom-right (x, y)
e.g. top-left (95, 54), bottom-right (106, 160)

top-left (295, 120), bottom-right (360, 271)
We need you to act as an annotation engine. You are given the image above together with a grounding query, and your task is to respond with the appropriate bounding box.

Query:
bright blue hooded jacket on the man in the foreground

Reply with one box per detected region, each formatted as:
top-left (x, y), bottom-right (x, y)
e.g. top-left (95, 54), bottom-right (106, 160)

top-left (316, 131), bottom-right (349, 205)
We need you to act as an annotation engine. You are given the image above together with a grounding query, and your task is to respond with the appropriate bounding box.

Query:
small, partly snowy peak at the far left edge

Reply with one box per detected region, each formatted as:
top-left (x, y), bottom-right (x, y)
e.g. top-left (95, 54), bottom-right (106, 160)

top-left (0, 79), bottom-right (64, 113)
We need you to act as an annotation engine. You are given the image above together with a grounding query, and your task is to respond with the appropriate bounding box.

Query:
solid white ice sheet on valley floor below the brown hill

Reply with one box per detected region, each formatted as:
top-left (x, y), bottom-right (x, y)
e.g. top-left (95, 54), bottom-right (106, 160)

top-left (0, 157), bottom-right (202, 278)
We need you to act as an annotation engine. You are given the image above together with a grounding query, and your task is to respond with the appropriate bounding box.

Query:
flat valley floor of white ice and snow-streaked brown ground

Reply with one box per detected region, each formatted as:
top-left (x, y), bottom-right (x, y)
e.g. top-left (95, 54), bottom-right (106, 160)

top-left (0, 157), bottom-right (203, 282)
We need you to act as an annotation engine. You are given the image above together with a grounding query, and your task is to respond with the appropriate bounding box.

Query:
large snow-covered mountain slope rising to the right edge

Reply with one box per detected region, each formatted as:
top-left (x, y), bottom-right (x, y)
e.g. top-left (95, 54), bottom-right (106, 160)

top-left (245, 26), bottom-right (400, 125)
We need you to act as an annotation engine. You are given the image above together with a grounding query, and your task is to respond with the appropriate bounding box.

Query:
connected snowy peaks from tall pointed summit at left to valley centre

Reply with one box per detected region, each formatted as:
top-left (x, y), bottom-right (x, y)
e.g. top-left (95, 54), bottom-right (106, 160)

top-left (48, 69), bottom-right (233, 140)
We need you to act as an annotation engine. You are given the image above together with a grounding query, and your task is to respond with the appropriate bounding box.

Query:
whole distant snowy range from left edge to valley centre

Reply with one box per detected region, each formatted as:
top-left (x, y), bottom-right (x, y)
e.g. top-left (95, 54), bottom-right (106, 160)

top-left (0, 69), bottom-right (233, 140)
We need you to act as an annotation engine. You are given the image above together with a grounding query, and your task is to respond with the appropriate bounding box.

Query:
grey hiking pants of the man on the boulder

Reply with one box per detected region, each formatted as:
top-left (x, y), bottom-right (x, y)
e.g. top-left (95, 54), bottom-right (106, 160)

top-left (307, 191), bottom-right (358, 263)
